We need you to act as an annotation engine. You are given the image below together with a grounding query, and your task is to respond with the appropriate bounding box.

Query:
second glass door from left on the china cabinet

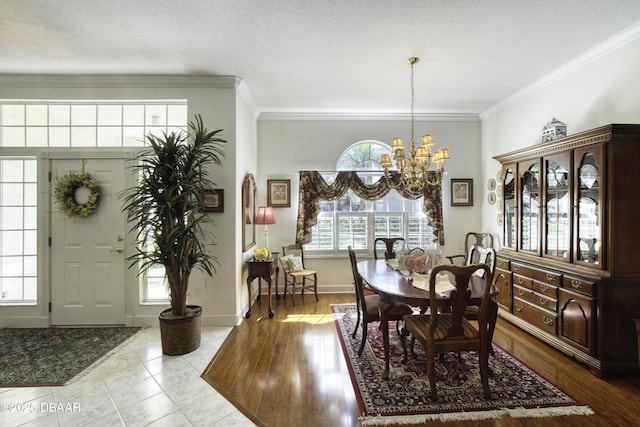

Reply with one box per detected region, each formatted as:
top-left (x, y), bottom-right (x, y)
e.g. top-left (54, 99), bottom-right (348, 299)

top-left (518, 160), bottom-right (540, 253)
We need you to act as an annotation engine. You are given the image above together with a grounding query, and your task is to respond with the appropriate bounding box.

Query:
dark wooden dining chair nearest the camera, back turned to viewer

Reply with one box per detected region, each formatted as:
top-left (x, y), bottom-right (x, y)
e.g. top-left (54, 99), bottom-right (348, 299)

top-left (400, 264), bottom-right (492, 402)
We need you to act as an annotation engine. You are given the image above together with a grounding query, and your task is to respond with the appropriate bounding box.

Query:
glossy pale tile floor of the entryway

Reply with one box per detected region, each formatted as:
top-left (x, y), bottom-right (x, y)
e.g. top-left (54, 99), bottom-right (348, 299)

top-left (0, 327), bottom-right (254, 427)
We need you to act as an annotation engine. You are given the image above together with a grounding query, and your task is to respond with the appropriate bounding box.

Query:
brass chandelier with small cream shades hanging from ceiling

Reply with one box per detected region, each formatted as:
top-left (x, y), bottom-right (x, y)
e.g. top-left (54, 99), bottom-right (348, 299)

top-left (380, 57), bottom-right (449, 197)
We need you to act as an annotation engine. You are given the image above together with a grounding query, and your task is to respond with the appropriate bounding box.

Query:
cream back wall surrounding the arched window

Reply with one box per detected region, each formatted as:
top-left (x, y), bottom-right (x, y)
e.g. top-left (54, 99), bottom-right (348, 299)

top-left (256, 120), bottom-right (482, 292)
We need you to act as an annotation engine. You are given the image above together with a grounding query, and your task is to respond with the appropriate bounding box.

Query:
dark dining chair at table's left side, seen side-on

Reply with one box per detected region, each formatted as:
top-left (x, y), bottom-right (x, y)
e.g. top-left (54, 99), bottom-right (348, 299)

top-left (348, 246), bottom-right (413, 356)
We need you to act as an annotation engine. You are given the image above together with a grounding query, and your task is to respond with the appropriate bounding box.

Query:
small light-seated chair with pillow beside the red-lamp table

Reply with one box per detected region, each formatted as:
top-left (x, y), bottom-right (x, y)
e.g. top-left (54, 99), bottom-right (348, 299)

top-left (279, 243), bottom-right (318, 305)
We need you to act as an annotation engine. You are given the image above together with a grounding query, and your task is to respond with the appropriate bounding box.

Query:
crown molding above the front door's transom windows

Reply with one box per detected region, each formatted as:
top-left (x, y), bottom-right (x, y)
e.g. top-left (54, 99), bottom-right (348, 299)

top-left (0, 74), bottom-right (242, 89)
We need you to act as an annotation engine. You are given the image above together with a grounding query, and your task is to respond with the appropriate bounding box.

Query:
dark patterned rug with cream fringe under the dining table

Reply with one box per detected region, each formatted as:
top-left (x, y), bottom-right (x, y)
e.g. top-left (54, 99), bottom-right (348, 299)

top-left (331, 304), bottom-right (593, 425)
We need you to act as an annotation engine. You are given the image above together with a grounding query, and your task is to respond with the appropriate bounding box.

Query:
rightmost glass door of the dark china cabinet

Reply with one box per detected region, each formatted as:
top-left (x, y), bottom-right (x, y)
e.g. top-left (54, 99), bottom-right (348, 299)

top-left (575, 145), bottom-right (604, 266)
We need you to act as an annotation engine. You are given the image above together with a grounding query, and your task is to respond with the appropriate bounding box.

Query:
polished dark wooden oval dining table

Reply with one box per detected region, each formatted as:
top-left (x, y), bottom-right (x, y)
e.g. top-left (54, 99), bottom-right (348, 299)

top-left (357, 260), bottom-right (499, 379)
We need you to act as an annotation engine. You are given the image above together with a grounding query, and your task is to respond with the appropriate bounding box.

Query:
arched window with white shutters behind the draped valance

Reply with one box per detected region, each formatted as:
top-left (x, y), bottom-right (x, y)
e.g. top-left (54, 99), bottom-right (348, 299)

top-left (305, 140), bottom-right (437, 255)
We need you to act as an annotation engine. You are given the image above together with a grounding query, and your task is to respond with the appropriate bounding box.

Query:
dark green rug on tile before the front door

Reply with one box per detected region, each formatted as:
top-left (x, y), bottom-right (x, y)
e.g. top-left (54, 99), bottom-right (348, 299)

top-left (0, 327), bottom-right (140, 387)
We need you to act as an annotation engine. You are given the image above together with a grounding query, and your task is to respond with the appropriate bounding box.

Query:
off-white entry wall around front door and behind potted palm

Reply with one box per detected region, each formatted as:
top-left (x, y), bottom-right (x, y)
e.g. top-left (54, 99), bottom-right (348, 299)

top-left (0, 75), bottom-right (249, 326)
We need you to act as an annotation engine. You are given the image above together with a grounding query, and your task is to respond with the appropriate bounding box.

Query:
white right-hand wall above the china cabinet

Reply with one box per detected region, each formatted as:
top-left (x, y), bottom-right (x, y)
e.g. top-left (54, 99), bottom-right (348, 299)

top-left (482, 38), bottom-right (640, 244)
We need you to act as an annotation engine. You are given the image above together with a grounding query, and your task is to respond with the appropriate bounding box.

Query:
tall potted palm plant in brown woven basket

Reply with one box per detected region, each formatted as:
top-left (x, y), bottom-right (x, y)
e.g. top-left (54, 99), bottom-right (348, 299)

top-left (119, 115), bottom-right (226, 355)
